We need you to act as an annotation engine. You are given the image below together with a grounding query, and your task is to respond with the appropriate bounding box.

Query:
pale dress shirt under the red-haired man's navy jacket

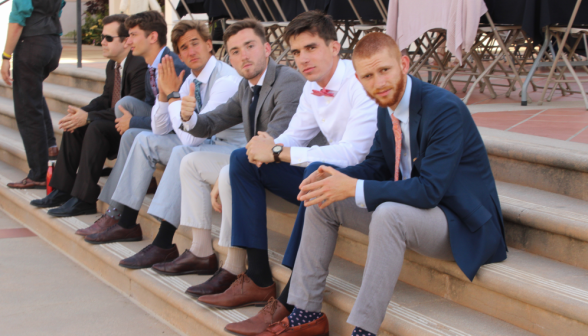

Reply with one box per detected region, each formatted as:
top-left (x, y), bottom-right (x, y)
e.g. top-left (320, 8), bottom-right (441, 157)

top-left (355, 76), bottom-right (412, 208)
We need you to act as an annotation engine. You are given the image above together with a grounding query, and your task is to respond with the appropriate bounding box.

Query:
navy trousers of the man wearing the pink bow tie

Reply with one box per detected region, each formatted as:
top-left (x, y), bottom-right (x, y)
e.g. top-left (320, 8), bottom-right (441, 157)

top-left (229, 148), bottom-right (323, 268)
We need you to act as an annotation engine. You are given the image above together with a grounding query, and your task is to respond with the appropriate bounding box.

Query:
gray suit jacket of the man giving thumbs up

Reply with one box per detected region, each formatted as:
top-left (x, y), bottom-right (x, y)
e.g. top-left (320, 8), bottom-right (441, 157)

top-left (189, 58), bottom-right (312, 141)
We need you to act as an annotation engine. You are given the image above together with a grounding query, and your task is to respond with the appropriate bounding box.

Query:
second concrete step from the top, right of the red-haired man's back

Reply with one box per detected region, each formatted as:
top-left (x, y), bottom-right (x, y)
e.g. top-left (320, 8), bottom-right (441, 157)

top-left (497, 181), bottom-right (588, 269)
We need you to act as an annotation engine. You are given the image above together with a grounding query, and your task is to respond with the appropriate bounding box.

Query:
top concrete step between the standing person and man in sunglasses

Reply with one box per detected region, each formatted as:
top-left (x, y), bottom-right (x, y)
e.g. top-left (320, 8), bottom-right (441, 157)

top-left (45, 64), bottom-right (106, 94)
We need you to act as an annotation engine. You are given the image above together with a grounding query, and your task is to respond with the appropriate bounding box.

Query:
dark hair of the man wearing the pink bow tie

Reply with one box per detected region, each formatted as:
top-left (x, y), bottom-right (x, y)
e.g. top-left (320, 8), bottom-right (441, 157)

top-left (284, 10), bottom-right (337, 44)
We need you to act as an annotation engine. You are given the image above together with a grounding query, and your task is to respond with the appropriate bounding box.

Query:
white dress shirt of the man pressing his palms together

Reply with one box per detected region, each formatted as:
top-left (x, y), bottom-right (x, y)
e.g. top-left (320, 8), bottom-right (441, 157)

top-left (151, 56), bottom-right (241, 146)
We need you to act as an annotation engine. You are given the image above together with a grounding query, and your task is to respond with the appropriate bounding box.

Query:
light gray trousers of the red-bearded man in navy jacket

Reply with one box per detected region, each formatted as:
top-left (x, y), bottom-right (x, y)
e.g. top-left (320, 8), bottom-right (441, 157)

top-left (288, 198), bottom-right (453, 334)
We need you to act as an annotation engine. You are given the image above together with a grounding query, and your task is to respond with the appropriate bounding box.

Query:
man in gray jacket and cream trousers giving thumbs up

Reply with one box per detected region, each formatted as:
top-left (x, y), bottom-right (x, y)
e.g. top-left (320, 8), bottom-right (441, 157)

top-left (145, 20), bottom-right (305, 284)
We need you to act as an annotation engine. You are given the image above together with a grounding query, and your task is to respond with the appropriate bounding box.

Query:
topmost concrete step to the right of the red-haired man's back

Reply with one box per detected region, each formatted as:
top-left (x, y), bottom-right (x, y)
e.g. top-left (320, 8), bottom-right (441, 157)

top-left (479, 127), bottom-right (588, 201)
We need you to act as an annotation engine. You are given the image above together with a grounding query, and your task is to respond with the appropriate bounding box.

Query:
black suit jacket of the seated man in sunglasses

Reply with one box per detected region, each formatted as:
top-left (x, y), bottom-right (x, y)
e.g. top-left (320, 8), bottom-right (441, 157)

top-left (82, 51), bottom-right (147, 121)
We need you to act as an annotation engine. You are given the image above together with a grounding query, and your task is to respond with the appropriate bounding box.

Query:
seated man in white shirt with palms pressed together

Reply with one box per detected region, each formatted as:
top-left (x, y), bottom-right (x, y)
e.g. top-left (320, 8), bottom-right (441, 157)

top-left (80, 21), bottom-right (246, 268)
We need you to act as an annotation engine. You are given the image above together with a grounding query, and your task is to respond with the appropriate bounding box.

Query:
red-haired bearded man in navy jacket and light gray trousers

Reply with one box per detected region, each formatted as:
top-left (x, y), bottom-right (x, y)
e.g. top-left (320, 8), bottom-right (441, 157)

top-left (260, 33), bottom-right (506, 336)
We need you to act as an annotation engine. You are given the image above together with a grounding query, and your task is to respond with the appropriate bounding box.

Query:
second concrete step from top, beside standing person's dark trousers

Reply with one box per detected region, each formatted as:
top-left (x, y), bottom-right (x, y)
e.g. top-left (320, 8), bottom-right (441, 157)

top-left (0, 81), bottom-right (99, 114)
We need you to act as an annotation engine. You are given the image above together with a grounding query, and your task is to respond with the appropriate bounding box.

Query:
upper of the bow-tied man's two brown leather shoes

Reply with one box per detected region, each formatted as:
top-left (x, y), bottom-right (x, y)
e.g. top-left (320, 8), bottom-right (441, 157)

top-left (198, 273), bottom-right (276, 308)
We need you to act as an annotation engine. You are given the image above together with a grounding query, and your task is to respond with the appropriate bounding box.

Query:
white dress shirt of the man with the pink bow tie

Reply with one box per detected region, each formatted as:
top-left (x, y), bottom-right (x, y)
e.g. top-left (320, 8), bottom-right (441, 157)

top-left (275, 60), bottom-right (378, 168)
